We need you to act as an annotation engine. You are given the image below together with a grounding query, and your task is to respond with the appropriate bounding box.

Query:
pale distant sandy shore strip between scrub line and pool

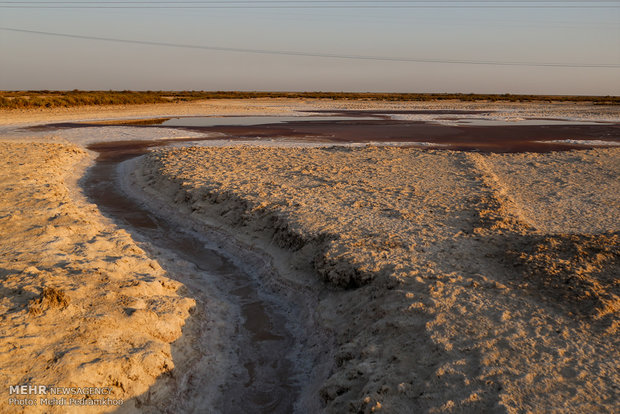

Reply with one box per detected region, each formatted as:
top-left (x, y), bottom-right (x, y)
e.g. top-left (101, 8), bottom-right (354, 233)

top-left (0, 98), bottom-right (620, 127)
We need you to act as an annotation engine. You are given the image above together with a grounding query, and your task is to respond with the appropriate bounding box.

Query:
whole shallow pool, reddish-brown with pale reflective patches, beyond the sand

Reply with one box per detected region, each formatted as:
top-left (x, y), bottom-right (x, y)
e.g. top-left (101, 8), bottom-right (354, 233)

top-left (23, 110), bottom-right (620, 153)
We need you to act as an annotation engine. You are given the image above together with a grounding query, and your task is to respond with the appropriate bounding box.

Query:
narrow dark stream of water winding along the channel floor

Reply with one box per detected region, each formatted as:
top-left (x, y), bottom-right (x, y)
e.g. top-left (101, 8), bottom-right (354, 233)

top-left (83, 141), bottom-right (300, 413)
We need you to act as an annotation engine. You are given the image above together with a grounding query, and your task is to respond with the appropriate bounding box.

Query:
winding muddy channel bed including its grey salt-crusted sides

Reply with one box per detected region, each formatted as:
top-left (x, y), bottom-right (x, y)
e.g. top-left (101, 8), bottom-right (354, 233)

top-left (105, 147), bottom-right (331, 413)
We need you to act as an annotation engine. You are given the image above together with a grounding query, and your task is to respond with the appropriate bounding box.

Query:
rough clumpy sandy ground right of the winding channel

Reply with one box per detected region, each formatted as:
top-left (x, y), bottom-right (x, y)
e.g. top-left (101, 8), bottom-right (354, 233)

top-left (135, 147), bottom-right (620, 413)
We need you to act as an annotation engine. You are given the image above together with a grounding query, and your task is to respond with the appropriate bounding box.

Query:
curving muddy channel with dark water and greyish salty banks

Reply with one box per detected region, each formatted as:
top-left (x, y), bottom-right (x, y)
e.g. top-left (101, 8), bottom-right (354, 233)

top-left (83, 141), bottom-right (334, 413)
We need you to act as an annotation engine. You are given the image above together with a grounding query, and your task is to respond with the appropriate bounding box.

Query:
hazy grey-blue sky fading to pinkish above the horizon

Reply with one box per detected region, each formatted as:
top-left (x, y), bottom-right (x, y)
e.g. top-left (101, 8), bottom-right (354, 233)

top-left (0, 0), bottom-right (620, 95)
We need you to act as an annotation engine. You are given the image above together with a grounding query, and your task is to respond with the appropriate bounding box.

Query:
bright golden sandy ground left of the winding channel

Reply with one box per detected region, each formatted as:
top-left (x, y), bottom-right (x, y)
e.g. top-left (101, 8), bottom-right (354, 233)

top-left (0, 142), bottom-right (220, 413)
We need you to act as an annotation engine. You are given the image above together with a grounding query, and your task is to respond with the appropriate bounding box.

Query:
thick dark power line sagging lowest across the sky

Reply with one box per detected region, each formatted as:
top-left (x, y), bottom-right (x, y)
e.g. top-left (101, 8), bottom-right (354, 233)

top-left (0, 27), bottom-right (620, 68)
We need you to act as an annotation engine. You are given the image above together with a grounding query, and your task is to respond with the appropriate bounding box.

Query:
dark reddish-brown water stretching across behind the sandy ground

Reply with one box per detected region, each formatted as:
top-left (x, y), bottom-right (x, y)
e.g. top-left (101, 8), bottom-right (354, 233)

top-left (34, 110), bottom-right (620, 152)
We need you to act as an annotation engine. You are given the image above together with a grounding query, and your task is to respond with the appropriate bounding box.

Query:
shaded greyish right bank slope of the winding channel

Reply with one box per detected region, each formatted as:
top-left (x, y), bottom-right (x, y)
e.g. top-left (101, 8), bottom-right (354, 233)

top-left (118, 156), bottom-right (335, 412)
